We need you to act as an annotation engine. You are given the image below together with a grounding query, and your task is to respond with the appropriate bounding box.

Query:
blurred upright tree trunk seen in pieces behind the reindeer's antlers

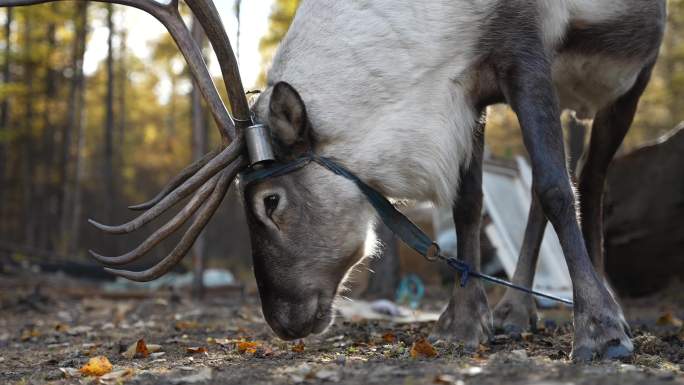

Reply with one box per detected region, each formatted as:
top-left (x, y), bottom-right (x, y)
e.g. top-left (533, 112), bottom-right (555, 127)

top-left (190, 18), bottom-right (209, 298)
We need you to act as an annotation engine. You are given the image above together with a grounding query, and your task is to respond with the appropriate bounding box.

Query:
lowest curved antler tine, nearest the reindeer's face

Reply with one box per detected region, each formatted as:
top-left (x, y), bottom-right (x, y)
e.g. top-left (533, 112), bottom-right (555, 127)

top-left (105, 157), bottom-right (246, 282)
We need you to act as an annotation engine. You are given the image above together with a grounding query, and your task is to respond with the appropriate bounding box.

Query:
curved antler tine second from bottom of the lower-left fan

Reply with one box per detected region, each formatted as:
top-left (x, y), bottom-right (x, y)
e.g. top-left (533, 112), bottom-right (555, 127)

top-left (89, 172), bottom-right (219, 266)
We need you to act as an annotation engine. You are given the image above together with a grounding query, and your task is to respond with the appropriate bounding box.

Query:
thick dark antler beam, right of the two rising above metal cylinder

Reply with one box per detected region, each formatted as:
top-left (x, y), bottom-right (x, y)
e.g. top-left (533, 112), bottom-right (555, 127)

top-left (185, 0), bottom-right (252, 128)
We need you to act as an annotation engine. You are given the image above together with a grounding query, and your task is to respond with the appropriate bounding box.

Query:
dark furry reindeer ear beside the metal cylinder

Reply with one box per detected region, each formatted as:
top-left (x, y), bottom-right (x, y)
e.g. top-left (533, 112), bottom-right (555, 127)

top-left (269, 82), bottom-right (310, 149)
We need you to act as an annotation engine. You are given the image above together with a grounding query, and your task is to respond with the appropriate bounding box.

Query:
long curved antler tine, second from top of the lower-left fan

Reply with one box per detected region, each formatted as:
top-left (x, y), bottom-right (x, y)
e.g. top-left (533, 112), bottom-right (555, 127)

top-left (88, 132), bottom-right (244, 234)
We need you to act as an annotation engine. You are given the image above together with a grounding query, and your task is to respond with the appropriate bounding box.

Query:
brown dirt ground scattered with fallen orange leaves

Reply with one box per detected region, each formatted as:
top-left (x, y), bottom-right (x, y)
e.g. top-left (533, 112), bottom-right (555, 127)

top-left (0, 275), bottom-right (684, 385)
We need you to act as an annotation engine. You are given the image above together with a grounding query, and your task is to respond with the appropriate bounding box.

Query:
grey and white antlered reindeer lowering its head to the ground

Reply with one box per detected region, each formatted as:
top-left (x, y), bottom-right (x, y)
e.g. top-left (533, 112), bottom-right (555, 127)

top-left (0, 0), bottom-right (665, 360)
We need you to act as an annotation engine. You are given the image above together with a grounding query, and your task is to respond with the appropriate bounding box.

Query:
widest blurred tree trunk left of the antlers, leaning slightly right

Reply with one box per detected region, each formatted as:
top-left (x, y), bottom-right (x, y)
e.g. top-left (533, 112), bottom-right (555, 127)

top-left (60, 2), bottom-right (88, 255)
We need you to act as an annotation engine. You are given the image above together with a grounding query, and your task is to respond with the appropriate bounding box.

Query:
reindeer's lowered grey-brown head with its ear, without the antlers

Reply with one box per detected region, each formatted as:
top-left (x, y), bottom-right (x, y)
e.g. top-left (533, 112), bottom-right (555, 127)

top-left (243, 82), bottom-right (371, 339)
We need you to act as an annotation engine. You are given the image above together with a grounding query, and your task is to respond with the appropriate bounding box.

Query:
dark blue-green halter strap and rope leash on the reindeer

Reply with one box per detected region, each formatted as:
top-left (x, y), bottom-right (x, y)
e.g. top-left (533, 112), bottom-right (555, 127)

top-left (241, 152), bottom-right (573, 306)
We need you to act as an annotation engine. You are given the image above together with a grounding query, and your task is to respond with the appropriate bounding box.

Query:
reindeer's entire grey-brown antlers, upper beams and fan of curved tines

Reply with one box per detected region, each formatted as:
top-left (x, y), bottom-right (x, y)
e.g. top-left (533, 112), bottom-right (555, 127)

top-left (0, 0), bottom-right (252, 281)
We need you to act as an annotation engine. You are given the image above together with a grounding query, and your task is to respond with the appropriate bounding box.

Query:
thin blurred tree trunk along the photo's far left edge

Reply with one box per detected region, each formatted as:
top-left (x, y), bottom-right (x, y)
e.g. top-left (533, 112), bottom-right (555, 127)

top-left (0, 8), bottom-right (13, 235)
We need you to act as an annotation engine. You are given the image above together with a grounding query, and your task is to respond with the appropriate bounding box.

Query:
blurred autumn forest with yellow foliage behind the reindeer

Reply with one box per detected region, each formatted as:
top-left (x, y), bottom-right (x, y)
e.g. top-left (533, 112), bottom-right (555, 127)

top-left (0, 0), bottom-right (684, 280)
